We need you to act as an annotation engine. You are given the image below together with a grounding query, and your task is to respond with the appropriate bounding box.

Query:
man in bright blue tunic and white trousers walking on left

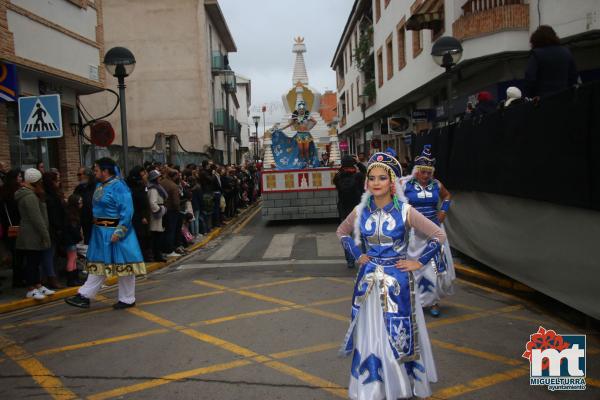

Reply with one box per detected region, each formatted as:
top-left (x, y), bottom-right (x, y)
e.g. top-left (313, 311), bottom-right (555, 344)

top-left (65, 158), bottom-right (146, 309)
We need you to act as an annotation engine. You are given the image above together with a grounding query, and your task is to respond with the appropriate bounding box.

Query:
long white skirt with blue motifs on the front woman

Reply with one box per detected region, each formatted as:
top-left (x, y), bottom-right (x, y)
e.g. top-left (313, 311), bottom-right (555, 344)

top-left (348, 285), bottom-right (437, 400)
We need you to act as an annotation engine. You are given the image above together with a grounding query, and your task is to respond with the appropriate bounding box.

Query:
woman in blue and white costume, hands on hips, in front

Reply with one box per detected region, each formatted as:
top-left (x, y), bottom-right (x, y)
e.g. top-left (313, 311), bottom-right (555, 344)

top-left (337, 153), bottom-right (446, 400)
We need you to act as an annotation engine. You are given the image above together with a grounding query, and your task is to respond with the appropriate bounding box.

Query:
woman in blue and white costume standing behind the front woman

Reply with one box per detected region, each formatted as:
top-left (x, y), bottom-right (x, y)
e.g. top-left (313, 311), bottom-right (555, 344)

top-left (400, 145), bottom-right (456, 317)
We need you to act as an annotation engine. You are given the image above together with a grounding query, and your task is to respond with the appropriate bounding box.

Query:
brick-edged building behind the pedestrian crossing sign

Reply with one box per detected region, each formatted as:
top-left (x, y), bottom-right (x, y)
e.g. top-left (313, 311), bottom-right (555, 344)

top-left (0, 0), bottom-right (105, 191)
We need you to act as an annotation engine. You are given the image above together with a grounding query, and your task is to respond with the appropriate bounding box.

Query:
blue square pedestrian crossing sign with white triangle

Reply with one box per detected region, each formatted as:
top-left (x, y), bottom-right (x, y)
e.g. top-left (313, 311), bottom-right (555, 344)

top-left (19, 94), bottom-right (63, 140)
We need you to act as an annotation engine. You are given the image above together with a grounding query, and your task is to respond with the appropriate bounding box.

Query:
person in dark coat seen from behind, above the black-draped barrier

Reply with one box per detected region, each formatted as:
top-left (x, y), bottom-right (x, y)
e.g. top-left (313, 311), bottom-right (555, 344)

top-left (525, 25), bottom-right (577, 98)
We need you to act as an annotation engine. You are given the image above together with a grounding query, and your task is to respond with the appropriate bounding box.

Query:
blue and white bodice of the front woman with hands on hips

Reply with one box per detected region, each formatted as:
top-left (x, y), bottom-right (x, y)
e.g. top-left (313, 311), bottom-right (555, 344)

top-left (360, 198), bottom-right (410, 258)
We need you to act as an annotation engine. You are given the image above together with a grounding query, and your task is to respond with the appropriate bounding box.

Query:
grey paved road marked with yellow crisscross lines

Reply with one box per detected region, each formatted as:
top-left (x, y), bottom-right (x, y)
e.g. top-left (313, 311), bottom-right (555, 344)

top-left (0, 208), bottom-right (600, 400)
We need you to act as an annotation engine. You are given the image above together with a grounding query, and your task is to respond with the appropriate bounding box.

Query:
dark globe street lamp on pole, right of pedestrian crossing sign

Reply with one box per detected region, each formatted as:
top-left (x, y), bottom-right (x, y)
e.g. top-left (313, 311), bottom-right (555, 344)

top-left (104, 47), bottom-right (135, 175)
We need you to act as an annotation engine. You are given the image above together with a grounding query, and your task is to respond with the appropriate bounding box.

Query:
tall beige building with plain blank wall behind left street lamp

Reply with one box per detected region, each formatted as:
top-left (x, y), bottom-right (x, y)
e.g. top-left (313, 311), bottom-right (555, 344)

top-left (82, 0), bottom-right (237, 164)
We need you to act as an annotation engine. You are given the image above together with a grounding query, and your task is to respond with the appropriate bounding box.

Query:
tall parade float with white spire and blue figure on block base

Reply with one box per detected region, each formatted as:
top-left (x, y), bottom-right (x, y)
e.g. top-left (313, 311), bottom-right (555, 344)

top-left (261, 37), bottom-right (340, 220)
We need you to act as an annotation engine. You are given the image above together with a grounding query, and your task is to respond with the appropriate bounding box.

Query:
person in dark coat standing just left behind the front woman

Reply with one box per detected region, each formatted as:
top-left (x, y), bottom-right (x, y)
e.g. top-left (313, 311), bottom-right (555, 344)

top-left (333, 155), bottom-right (365, 268)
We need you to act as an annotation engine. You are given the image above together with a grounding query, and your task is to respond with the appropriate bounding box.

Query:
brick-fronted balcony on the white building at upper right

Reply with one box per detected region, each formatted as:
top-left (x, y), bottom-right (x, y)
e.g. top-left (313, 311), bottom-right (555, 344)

top-left (452, 0), bottom-right (529, 40)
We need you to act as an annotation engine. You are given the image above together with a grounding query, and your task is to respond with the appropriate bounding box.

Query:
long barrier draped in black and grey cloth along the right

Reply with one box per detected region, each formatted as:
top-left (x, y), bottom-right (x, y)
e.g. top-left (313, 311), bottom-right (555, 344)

top-left (414, 83), bottom-right (600, 319)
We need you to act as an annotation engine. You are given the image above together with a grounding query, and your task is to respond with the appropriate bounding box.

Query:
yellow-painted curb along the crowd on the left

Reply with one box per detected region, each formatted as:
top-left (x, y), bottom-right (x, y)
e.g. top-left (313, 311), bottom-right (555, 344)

top-left (0, 200), bottom-right (261, 314)
